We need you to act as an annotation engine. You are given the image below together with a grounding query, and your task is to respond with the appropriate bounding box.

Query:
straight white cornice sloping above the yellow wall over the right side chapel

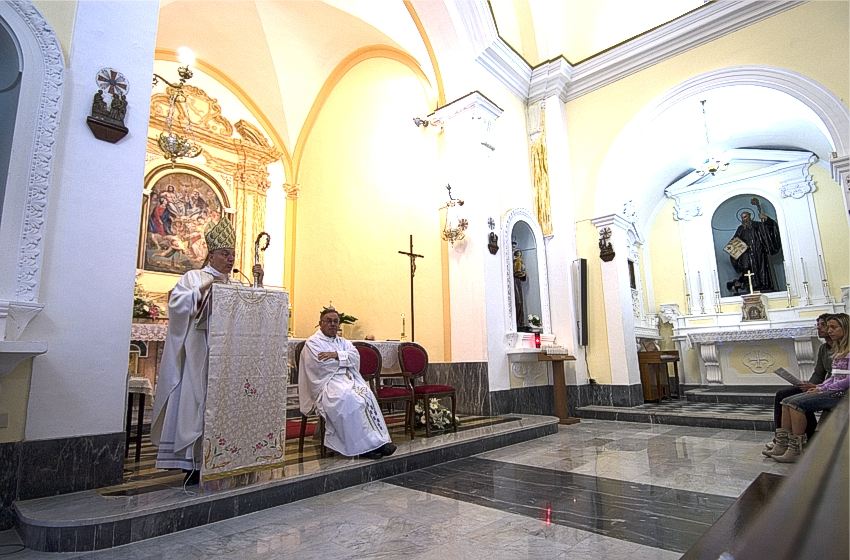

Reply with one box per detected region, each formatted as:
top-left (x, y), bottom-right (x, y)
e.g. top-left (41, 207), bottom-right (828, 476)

top-left (566, 0), bottom-right (803, 101)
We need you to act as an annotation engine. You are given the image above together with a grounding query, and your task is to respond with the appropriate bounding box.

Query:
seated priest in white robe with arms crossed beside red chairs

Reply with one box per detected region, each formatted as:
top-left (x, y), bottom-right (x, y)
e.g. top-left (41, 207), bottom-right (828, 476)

top-left (298, 307), bottom-right (396, 459)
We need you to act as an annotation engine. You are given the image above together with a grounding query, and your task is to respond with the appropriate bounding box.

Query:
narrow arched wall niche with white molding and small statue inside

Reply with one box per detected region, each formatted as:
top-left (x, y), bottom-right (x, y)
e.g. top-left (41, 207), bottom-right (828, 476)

top-left (502, 208), bottom-right (552, 334)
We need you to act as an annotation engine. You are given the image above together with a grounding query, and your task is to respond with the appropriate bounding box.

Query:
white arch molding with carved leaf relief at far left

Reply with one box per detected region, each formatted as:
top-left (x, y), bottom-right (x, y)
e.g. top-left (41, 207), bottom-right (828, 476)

top-left (4, 0), bottom-right (65, 302)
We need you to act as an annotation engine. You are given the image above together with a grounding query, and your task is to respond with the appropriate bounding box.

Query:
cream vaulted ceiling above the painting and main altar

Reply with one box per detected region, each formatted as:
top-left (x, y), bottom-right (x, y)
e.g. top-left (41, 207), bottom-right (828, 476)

top-left (157, 0), bottom-right (434, 153)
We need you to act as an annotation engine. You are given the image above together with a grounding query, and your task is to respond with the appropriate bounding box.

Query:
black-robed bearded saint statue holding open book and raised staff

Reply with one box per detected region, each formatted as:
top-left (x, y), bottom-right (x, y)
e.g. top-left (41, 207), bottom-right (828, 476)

top-left (723, 198), bottom-right (782, 295)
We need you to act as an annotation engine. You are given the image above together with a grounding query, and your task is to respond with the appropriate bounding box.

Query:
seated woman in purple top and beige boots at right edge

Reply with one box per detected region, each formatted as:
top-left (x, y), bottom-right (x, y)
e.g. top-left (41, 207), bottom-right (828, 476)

top-left (767, 313), bottom-right (850, 463)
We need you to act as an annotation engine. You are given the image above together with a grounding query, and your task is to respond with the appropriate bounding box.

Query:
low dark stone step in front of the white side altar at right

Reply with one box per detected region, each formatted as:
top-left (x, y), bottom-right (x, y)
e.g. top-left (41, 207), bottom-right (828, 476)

top-left (576, 393), bottom-right (773, 432)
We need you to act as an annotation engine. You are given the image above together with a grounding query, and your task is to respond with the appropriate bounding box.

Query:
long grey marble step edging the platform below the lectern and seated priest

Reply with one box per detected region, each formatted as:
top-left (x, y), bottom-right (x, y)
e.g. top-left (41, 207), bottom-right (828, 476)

top-left (14, 414), bottom-right (558, 552)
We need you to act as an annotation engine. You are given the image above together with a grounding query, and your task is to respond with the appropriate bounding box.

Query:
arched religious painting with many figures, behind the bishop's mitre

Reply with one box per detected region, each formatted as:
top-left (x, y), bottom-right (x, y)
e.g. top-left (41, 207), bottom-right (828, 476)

top-left (138, 165), bottom-right (230, 274)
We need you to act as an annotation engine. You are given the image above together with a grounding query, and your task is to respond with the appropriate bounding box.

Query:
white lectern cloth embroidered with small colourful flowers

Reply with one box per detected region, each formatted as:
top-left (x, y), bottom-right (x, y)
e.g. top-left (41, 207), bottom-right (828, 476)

top-left (201, 284), bottom-right (289, 480)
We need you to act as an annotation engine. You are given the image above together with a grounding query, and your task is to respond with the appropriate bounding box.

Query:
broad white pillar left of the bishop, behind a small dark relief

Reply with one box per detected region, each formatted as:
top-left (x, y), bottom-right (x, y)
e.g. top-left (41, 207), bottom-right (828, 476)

top-left (25, 1), bottom-right (159, 440)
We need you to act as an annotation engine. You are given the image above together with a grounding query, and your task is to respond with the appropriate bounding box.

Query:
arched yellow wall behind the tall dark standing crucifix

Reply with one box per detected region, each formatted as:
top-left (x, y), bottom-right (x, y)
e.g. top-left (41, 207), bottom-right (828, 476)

top-left (293, 59), bottom-right (444, 361)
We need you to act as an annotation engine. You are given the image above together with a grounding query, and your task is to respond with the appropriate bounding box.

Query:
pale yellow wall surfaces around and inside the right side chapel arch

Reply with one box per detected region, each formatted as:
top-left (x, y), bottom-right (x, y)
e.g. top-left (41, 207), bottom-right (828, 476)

top-left (566, 2), bottom-right (850, 383)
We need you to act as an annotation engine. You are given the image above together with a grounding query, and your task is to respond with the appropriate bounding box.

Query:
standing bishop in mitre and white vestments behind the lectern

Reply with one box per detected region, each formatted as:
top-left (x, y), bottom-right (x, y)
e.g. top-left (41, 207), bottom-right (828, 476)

top-left (151, 217), bottom-right (263, 483)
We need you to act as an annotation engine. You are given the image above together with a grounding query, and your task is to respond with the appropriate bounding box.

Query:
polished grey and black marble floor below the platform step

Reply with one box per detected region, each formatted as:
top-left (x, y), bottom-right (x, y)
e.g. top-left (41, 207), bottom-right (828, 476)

top-left (0, 420), bottom-right (793, 560)
